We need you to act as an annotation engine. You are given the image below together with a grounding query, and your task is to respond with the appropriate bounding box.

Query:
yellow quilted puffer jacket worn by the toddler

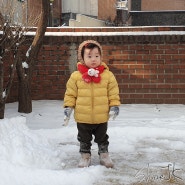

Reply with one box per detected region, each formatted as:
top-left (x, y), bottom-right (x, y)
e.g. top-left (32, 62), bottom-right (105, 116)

top-left (64, 62), bottom-right (120, 124)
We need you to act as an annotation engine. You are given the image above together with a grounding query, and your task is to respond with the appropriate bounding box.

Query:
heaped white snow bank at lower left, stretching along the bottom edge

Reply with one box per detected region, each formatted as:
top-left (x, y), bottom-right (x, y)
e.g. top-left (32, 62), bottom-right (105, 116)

top-left (0, 116), bottom-right (102, 185)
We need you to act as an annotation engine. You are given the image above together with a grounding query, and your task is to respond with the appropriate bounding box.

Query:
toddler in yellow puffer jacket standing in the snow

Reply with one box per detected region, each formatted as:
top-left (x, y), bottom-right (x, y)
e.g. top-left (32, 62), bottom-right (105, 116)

top-left (64, 40), bottom-right (120, 168)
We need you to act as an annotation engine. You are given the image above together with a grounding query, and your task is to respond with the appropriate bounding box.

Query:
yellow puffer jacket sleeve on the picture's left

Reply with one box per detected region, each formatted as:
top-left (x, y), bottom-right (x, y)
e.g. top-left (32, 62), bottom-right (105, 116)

top-left (63, 73), bottom-right (77, 107)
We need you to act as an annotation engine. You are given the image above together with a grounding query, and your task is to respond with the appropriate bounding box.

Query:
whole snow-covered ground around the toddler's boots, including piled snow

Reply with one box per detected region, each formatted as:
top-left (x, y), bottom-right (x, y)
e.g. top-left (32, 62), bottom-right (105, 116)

top-left (0, 100), bottom-right (185, 185)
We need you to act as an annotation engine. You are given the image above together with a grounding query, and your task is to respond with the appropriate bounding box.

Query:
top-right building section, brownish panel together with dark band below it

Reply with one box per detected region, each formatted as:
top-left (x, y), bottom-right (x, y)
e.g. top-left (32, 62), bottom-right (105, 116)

top-left (128, 0), bottom-right (185, 26)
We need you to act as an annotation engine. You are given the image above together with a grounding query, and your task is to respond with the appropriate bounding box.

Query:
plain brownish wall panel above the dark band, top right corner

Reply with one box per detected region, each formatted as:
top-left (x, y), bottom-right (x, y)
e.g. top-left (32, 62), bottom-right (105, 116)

top-left (141, 0), bottom-right (185, 11)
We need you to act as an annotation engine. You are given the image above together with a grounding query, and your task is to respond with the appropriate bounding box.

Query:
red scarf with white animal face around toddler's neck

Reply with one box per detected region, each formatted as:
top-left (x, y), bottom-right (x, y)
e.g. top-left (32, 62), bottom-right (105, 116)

top-left (78, 64), bottom-right (105, 83)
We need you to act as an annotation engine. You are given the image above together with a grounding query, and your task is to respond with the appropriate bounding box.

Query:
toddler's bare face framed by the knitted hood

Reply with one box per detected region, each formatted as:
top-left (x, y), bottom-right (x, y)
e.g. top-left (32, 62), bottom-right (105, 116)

top-left (84, 47), bottom-right (101, 68)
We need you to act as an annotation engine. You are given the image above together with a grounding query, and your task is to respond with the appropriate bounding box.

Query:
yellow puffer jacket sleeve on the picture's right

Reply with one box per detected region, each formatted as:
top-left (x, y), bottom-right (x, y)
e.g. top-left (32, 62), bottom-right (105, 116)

top-left (108, 72), bottom-right (120, 107)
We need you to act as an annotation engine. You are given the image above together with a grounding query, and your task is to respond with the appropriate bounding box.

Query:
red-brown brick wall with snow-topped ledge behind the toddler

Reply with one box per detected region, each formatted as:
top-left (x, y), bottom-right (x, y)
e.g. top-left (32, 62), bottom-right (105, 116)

top-left (3, 27), bottom-right (185, 104)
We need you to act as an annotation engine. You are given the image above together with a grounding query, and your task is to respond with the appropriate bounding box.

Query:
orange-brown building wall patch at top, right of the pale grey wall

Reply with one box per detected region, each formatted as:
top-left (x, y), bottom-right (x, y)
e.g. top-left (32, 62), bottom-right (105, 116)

top-left (98, 0), bottom-right (117, 21)
